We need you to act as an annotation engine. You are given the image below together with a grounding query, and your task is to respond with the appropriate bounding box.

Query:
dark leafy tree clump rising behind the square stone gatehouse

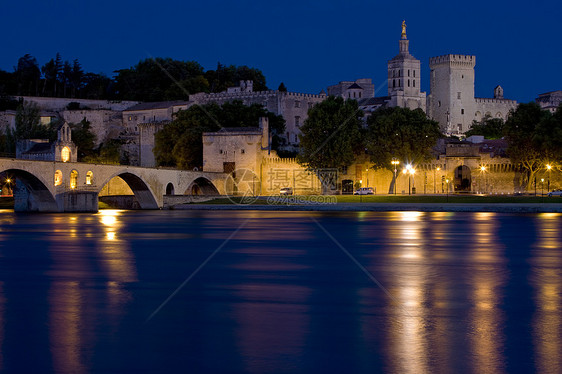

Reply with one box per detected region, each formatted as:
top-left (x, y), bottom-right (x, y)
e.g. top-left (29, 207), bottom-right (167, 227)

top-left (154, 101), bottom-right (285, 169)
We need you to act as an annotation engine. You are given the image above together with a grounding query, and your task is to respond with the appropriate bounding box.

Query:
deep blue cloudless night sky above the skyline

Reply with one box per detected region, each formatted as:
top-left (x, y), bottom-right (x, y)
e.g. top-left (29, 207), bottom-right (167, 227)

top-left (0, 0), bottom-right (562, 102)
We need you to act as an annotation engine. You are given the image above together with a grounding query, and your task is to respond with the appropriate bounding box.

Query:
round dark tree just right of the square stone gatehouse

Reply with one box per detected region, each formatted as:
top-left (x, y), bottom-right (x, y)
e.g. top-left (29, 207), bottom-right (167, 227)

top-left (297, 96), bottom-right (364, 170)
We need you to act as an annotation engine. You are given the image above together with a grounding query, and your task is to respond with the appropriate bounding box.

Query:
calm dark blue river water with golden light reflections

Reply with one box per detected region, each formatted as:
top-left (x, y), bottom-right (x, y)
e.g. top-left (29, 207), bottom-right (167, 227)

top-left (0, 211), bottom-right (562, 373)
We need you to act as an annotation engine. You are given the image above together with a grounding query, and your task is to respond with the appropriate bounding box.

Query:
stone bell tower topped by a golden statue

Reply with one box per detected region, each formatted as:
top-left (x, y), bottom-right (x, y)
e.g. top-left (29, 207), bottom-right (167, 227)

top-left (388, 21), bottom-right (426, 112)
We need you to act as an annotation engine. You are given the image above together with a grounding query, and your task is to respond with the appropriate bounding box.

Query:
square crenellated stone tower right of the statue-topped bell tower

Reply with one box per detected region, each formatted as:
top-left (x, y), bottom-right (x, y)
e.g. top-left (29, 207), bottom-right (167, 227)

top-left (427, 55), bottom-right (476, 135)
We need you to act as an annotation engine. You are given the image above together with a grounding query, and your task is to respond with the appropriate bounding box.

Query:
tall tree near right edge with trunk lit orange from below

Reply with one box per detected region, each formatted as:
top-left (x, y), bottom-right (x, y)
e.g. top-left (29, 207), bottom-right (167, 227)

top-left (505, 103), bottom-right (548, 189)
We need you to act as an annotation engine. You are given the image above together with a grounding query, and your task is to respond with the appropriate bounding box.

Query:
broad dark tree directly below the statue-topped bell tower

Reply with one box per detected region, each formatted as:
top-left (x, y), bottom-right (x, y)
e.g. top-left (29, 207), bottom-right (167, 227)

top-left (366, 107), bottom-right (441, 191)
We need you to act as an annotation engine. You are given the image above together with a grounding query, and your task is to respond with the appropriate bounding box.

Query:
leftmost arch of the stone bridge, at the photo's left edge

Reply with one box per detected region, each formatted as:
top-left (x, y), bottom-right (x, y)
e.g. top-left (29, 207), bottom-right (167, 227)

top-left (0, 169), bottom-right (58, 212)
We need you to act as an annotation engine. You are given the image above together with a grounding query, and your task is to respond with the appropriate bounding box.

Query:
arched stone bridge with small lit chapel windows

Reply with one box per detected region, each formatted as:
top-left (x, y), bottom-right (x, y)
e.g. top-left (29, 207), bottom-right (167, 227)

top-left (0, 158), bottom-right (226, 212)
